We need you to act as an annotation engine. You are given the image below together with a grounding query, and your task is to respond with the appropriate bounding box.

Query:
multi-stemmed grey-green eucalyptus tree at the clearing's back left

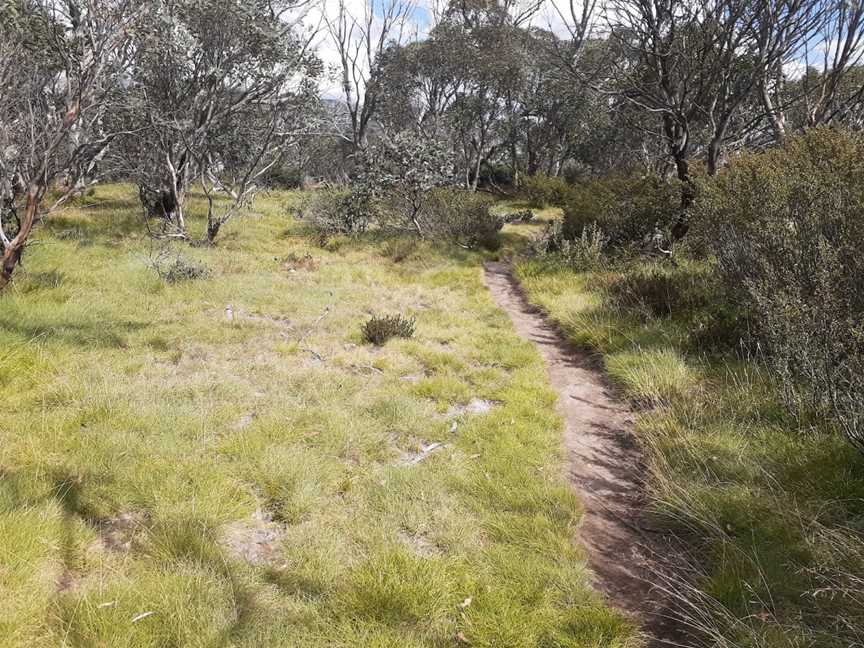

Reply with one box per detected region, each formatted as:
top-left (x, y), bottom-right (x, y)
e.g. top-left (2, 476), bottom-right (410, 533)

top-left (114, 0), bottom-right (320, 243)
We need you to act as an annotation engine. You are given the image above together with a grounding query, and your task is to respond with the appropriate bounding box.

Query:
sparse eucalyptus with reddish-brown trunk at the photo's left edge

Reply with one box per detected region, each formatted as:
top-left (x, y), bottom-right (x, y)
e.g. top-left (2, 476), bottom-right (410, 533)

top-left (0, 0), bottom-right (136, 289)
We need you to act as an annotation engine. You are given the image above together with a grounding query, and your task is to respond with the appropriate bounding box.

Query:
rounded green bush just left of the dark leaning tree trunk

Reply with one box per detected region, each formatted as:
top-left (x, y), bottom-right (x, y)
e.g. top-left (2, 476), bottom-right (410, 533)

top-left (563, 176), bottom-right (680, 247)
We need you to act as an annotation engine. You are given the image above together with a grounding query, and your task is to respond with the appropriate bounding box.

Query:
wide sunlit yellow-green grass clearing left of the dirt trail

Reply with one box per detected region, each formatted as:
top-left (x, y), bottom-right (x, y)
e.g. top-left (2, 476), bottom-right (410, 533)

top-left (0, 186), bottom-right (639, 648)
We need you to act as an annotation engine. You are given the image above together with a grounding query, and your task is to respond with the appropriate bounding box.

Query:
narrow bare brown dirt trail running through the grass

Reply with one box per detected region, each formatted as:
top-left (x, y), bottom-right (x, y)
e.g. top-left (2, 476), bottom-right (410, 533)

top-left (485, 262), bottom-right (686, 647)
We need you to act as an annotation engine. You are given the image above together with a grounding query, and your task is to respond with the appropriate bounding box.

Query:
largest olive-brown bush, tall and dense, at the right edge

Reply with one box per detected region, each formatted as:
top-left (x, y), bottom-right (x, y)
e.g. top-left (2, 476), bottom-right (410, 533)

top-left (697, 129), bottom-right (864, 449)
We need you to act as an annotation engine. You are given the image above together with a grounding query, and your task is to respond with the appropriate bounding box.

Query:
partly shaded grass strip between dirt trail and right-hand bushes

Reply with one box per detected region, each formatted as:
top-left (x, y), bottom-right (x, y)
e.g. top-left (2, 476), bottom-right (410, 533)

top-left (517, 260), bottom-right (864, 648)
